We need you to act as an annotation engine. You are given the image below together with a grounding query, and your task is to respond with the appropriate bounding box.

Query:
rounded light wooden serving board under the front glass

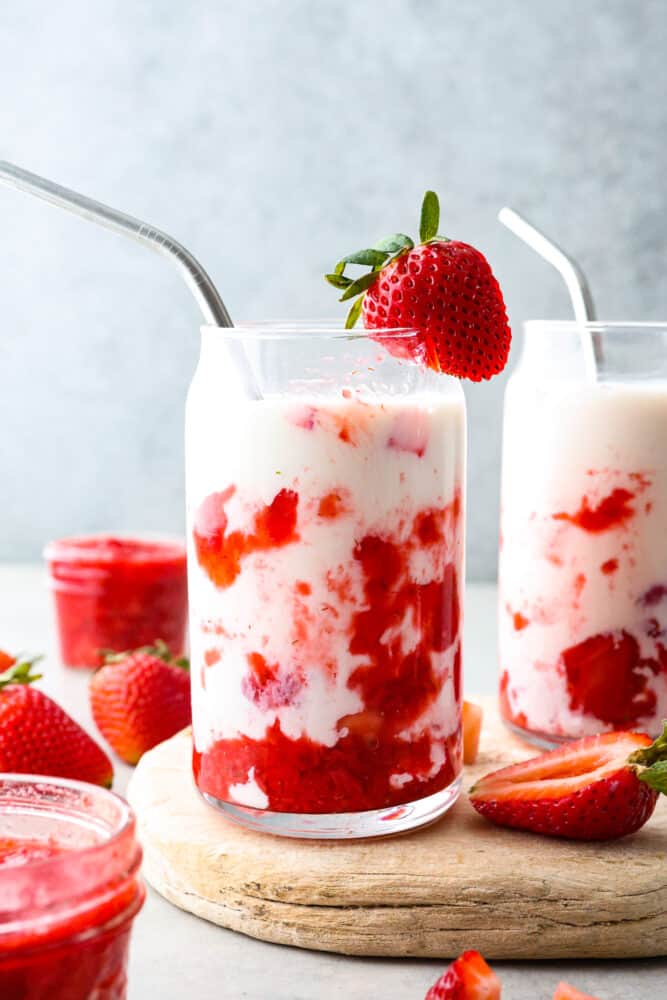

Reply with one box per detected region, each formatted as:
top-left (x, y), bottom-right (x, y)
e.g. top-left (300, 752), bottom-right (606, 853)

top-left (129, 700), bottom-right (667, 959)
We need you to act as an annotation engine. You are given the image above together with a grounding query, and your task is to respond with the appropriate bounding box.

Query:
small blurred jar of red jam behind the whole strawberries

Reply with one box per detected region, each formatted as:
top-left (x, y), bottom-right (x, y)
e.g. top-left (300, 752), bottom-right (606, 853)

top-left (44, 535), bottom-right (187, 667)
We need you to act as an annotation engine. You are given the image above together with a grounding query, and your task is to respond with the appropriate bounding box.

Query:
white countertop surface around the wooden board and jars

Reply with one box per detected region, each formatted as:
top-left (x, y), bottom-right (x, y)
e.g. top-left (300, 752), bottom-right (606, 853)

top-left (0, 565), bottom-right (667, 1000)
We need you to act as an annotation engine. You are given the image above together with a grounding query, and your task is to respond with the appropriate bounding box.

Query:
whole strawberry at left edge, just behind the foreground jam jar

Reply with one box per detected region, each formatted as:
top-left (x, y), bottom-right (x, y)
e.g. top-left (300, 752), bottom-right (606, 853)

top-left (0, 653), bottom-right (113, 788)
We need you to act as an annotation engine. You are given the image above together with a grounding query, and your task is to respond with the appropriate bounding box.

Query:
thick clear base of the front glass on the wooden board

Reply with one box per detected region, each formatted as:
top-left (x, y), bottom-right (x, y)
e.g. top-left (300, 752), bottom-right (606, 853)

top-left (201, 776), bottom-right (461, 840)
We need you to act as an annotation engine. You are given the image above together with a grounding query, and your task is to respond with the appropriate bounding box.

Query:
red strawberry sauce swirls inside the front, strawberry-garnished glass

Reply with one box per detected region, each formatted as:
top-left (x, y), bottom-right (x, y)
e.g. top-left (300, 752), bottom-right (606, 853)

top-left (193, 488), bottom-right (462, 813)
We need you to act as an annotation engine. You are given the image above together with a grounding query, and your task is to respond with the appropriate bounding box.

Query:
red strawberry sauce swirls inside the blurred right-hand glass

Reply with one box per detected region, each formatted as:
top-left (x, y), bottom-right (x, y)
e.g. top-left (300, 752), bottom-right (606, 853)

top-left (500, 471), bottom-right (667, 736)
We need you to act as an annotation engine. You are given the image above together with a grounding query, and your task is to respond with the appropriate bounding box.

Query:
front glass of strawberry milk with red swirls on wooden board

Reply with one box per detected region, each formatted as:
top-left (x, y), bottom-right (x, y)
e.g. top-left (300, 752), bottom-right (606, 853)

top-left (186, 324), bottom-right (465, 838)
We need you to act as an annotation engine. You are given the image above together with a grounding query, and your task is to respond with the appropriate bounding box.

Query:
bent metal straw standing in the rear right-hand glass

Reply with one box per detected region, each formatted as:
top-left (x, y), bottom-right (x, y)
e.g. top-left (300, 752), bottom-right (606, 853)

top-left (498, 206), bottom-right (602, 381)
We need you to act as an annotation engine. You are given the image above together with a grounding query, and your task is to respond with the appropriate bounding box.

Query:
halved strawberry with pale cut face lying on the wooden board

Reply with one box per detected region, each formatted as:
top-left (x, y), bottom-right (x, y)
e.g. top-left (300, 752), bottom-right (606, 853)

top-left (470, 723), bottom-right (667, 840)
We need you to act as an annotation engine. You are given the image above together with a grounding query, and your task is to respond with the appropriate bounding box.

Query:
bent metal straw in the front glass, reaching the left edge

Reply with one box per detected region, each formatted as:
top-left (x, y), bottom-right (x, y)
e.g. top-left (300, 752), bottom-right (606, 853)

top-left (0, 160), bottom-right (261, 399)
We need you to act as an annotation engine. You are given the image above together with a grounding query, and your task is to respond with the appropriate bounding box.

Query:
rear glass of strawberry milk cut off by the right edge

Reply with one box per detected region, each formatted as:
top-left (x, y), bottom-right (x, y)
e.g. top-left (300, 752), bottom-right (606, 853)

top-left (499, 321), bottom-right (667, 744)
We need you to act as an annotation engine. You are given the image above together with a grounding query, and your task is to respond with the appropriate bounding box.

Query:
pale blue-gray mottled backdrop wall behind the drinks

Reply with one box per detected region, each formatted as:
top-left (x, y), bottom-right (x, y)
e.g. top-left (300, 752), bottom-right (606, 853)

top-left (0, 0), bottom-right (667, 579)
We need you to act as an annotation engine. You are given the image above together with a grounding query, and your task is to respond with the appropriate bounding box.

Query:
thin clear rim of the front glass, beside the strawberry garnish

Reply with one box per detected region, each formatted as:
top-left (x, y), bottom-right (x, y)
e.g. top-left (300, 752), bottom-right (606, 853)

top-left (201, 319), bottom-right (419, 341)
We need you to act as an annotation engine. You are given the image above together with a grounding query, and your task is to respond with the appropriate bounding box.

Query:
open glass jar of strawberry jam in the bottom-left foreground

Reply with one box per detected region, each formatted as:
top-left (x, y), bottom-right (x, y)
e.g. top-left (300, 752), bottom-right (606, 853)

top-left (0, 774), bottom-right (145, 1000)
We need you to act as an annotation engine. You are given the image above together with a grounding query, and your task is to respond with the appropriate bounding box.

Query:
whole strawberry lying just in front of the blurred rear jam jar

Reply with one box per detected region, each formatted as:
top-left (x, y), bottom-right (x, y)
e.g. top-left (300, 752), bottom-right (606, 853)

top-left (90, 643), bottom-right (191, 764)
